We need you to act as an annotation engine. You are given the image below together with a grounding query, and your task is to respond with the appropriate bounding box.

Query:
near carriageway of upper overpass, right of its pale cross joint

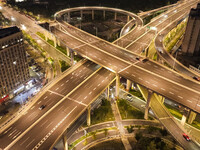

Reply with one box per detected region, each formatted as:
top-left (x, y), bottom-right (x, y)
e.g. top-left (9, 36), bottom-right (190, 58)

top-left (120, 66), bottom-right (200, 112)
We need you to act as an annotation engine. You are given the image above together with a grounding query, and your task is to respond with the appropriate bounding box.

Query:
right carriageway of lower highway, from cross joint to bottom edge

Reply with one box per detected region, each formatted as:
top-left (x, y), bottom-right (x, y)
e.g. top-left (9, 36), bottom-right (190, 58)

top-left (10, 98), bottom-right (85, 150)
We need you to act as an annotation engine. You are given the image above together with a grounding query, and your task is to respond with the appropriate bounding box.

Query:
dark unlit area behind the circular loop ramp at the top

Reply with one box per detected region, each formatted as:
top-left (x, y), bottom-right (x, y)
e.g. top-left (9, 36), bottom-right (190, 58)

top-left (7, 0), bottom-right (177, 17)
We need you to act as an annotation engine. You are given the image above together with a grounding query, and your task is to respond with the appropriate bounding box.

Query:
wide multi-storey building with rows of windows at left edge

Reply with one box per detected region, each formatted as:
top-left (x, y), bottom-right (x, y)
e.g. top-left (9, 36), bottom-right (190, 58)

top-left (0, 26), bottom-right (30, 99)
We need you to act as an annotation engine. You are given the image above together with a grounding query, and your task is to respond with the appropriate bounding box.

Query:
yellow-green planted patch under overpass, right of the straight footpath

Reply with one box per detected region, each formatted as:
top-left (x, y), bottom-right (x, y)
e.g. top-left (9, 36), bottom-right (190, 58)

top-left (117, 99), bottom-right (144, 119)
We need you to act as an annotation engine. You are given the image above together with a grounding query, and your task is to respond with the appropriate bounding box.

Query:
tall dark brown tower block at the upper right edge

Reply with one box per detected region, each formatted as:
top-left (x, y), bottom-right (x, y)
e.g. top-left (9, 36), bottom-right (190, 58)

top-left (182, 3), bottom-right (200, 56)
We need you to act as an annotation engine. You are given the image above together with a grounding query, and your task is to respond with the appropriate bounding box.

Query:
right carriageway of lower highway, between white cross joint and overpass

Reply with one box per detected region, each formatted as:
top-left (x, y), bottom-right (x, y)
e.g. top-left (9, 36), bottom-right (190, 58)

top-left (69, 68), bottom-right (115, 105)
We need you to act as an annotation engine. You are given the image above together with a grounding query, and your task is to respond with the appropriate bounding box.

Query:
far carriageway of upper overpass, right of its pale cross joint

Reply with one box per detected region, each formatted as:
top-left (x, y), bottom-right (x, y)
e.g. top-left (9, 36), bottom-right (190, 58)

top-left (137, 61), bottom-right (200, 91)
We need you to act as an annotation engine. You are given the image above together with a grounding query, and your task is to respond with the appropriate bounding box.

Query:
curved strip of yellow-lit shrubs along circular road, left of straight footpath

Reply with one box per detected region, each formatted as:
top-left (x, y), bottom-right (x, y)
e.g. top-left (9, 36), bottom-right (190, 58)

top-left (69, 127), bottom-right (117, 150)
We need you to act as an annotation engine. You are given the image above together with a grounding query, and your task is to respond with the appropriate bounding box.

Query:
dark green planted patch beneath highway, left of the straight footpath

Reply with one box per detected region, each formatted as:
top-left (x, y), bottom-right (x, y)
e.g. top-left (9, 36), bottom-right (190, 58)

top-left (91, 99), bottom-right (114, 125)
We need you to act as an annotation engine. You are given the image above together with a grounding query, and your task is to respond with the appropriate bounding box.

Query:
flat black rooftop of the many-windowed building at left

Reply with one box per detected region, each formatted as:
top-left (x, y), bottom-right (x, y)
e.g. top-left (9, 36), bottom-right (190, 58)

top-left (0, 26), bottom-right (20, 39)
